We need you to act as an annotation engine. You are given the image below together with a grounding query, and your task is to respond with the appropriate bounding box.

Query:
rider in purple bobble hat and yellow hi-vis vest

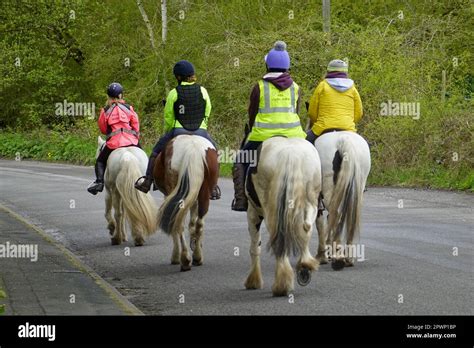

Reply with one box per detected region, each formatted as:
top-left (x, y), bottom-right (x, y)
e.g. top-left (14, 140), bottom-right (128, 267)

top-left (232, 41), bottom-right (306, 211)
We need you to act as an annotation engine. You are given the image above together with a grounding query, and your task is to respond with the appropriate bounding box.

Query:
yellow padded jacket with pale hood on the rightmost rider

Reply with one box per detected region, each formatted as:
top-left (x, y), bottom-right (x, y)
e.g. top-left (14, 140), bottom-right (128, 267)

top-left (308, 78), bottom-right (362, 135)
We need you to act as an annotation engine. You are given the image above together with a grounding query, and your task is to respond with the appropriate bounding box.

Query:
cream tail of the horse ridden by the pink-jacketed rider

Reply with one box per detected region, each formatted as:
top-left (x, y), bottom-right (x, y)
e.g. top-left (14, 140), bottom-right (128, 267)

top-left (115, 152), bottom-right (158, 236)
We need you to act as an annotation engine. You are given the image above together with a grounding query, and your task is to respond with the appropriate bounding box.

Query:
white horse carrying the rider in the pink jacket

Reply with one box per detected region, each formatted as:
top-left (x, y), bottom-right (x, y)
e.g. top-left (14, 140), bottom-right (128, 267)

top-left (96, 136), bottom-right (158, 246)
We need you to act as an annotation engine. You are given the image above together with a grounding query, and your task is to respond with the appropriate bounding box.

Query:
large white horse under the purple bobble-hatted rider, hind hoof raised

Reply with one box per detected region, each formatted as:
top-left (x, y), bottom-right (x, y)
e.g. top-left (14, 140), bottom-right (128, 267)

top-left (245, 137), bottom-right (321, 296)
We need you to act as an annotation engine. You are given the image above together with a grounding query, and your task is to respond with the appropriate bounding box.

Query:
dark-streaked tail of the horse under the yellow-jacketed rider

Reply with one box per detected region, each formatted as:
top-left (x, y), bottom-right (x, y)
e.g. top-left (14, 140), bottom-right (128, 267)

top-left (328, 135), bottom-right (363, 240)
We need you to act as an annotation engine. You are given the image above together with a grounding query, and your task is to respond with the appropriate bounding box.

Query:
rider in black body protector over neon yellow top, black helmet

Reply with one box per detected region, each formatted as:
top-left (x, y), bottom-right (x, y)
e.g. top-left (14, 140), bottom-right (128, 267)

top-left (135, 60), bottom-right (221, 199)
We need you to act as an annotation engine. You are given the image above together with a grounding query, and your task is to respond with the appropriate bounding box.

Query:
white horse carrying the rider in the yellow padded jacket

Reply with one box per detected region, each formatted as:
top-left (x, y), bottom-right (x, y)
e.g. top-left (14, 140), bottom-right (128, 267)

top-left (315, 131), bottom-right (370, 270)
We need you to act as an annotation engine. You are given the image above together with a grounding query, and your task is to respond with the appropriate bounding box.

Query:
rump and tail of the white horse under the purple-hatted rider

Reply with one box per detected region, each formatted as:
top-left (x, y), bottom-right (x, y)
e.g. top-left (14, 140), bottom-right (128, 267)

top-left (252, 138), bottom-right (321, 257)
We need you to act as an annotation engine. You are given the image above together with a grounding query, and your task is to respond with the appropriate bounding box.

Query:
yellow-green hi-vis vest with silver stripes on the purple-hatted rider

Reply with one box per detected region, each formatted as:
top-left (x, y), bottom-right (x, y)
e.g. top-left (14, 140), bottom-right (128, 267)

top-left (249, 80), bottom-right (306, 141)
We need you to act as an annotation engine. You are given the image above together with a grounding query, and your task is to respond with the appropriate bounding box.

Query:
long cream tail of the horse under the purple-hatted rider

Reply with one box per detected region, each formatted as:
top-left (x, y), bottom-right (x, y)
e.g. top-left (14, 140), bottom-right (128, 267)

top-left (267, 151), bottom-right (311, 258)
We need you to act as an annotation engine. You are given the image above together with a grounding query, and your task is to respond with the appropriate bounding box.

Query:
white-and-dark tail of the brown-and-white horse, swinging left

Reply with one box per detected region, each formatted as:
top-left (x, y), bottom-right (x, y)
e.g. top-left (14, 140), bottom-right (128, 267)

top-left (158, 141), bottom-right (206, 234)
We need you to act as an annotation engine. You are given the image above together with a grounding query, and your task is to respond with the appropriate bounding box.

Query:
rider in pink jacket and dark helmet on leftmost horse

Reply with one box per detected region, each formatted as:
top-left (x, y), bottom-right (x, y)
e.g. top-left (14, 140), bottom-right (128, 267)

top-left (87, 82), bottom-right (140, 195)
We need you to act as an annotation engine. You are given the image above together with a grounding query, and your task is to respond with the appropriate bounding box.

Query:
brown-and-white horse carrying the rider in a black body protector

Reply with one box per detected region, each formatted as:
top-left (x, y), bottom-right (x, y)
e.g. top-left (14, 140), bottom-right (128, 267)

top-left (153, 135), bottom-right (219, 271)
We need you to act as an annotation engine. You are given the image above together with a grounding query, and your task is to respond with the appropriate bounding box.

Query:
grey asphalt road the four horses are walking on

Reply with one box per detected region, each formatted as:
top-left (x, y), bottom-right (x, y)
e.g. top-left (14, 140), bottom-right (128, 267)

top-left (0, 160), bottom-right (474, 315)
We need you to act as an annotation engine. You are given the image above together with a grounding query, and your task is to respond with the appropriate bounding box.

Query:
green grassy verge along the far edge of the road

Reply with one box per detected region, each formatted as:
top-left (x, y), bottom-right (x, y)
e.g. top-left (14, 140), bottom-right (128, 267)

top-left (0, 125), bottom-right (474, 191)
